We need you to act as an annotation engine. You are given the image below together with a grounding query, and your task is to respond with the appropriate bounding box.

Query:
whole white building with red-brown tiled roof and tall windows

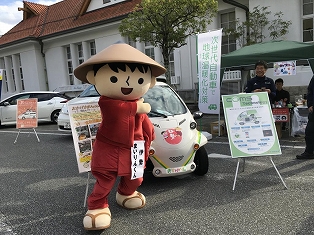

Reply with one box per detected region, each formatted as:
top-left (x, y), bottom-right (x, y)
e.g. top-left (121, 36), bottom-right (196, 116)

top-left (0, 0), bottom-right (314, 100)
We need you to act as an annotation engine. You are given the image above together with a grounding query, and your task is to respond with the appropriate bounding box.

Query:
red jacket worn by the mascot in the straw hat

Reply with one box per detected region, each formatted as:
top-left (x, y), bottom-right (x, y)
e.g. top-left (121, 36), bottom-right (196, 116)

top-left (91, 96), bottom-right (155, 176)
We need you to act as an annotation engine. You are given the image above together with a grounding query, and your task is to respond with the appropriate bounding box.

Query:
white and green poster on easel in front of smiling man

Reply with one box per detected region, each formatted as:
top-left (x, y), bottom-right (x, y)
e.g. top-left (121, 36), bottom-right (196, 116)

top-left (222, 92), bottom-right (281, 158)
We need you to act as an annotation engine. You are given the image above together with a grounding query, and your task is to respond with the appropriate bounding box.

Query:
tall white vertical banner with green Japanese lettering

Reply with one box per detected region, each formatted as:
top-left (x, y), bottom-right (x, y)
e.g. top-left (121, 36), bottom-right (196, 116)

top-left (197, 29), bottom-right (222, 114)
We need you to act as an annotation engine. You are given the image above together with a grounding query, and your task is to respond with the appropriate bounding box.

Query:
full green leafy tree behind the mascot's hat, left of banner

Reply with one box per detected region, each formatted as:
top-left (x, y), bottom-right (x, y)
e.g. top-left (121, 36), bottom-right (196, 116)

top-left (119, 0), bottom-right (218, 83)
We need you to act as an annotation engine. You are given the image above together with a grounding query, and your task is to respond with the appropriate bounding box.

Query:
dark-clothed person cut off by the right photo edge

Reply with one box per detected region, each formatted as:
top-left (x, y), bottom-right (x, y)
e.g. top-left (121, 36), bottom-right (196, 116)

top-left (297, 76), bottom-right (314, 159)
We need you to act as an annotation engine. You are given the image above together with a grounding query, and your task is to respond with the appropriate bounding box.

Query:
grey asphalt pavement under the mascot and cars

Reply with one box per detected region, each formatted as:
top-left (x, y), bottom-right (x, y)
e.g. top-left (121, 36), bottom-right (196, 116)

top-left (0, 120), bottom-right (314, 235)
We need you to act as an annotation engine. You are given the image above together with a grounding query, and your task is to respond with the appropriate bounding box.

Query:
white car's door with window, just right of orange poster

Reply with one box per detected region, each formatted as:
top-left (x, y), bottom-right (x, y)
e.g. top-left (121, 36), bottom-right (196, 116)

top-left (31, 93), bottom-right (55, 119)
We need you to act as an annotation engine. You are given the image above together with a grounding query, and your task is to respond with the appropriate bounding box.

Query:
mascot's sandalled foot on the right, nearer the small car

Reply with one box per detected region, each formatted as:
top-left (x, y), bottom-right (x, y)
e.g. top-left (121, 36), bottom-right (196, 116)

top-left (116, 191), bottom-right (146, 210)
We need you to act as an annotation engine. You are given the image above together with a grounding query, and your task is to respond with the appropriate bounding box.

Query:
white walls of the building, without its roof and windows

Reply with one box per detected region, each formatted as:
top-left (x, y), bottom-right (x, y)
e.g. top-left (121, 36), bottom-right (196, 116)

top-left (0, 0), bottom-right (312, 101)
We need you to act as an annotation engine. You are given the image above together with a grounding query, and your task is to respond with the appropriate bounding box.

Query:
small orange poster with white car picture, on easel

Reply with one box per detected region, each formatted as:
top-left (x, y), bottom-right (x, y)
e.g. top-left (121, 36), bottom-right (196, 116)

top-left (16, 98), bottom-right (38, 129)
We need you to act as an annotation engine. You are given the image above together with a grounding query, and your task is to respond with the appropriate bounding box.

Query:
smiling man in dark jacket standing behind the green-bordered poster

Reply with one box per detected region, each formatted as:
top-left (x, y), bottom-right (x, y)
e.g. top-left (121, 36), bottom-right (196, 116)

top-left (244, 61), bottom-right (276, 104)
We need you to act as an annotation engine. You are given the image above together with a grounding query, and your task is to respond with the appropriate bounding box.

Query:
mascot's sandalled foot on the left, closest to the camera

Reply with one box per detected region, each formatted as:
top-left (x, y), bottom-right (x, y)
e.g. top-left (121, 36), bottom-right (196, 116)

top-left (83, 208), bottom-right (111, 230)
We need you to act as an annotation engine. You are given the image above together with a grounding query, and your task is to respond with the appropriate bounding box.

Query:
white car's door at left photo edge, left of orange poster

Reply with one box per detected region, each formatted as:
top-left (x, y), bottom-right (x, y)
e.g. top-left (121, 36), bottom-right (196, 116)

top-left (0, 93), bottom-right (30, 124)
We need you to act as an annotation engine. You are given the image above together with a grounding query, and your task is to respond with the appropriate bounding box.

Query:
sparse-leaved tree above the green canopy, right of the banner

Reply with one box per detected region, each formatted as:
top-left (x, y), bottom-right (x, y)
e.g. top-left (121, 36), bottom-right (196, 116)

top-left (224, 6), bottom-right (292, 47)
